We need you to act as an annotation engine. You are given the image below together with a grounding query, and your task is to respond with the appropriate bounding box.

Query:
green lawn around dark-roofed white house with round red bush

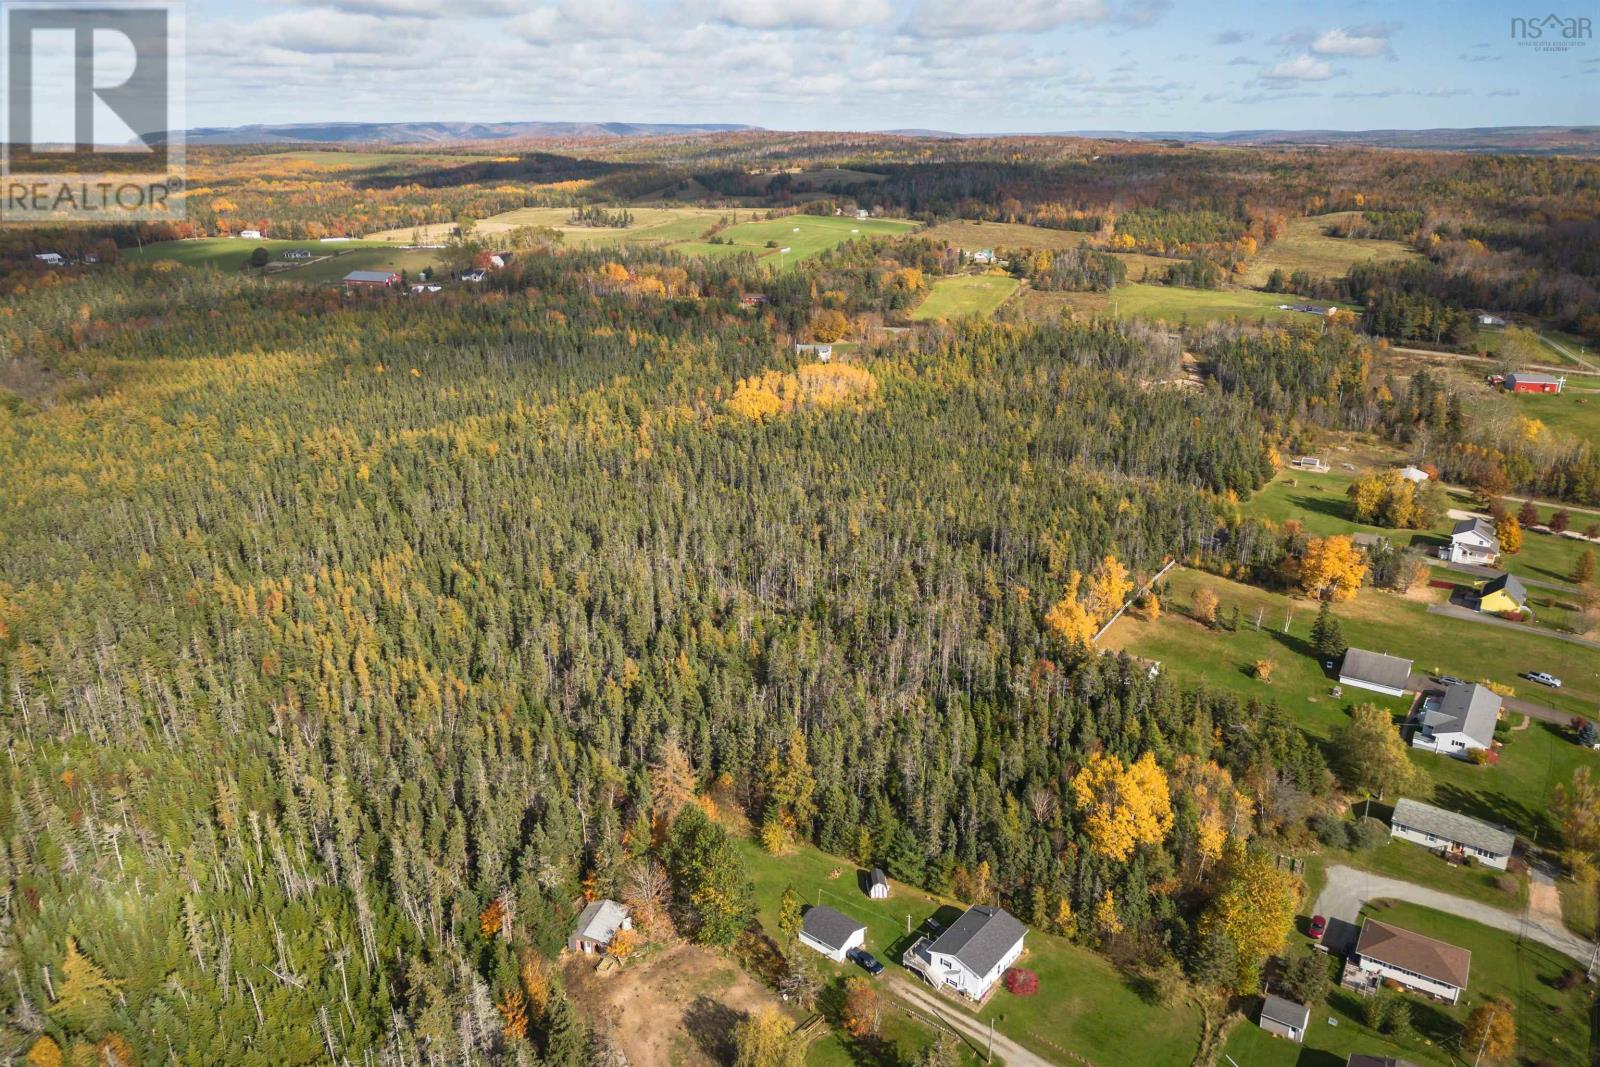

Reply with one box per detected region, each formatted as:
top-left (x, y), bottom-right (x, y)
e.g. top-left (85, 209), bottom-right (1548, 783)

top-left (741, 841), bottom-right (1200, 1067)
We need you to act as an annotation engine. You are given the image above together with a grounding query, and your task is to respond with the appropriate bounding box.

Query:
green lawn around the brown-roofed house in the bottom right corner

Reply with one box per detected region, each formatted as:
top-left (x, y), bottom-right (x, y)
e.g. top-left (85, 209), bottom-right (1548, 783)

top-left (1226, 901), bottom-right (1589, 1067)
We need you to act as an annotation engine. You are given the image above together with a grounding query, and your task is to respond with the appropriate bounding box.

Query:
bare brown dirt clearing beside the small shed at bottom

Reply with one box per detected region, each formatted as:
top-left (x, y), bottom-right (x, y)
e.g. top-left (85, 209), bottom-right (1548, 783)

top-left (565, 944), bottom-right (778, 1067)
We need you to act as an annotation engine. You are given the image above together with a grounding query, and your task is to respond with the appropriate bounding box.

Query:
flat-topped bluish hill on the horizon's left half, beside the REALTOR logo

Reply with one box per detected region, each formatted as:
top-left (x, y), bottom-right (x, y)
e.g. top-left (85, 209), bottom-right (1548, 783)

top-left (187, 122), bottom-right (758, 144)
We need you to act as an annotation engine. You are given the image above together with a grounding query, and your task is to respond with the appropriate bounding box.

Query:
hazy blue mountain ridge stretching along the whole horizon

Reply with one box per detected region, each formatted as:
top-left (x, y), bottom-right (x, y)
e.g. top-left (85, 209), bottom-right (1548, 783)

top-left (187, 122), bottom-right (1600, 155)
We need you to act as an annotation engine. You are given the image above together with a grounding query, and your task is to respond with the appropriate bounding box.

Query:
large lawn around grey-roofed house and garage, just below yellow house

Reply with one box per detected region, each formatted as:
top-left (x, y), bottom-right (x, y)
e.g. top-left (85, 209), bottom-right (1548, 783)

top-left (1101, 569), bottom-right (1600, 840)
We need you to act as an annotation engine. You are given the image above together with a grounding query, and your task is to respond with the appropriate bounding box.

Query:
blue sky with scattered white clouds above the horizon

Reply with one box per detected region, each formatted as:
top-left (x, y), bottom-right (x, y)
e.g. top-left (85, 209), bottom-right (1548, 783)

top-left (168, 0), bottom-right (1600, 133)
